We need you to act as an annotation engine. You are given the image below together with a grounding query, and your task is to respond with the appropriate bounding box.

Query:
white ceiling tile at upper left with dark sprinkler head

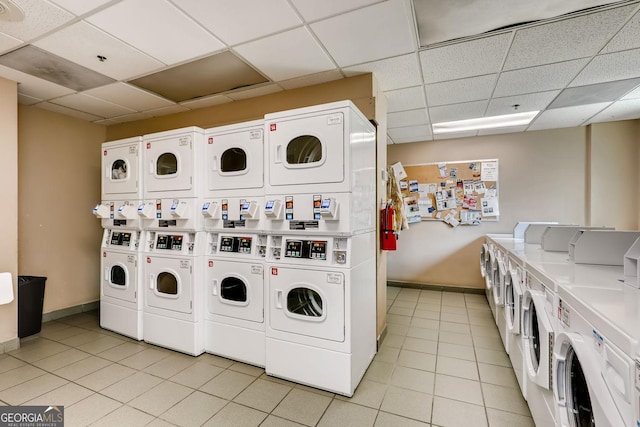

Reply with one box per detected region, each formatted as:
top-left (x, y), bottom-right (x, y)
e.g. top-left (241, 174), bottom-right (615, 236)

top-left (34, 22), bottom-right (164, 80)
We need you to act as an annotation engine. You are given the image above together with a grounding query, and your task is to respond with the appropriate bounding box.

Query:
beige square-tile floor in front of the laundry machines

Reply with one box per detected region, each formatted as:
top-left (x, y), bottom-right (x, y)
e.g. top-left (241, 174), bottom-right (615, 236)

top-left (0, 287), bottom-right (534, 427)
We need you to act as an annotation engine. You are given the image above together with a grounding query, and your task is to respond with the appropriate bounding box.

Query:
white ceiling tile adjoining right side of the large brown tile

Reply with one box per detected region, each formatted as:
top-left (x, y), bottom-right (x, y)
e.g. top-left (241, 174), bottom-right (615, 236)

top-left (234, 27), bottom-right (335, 82)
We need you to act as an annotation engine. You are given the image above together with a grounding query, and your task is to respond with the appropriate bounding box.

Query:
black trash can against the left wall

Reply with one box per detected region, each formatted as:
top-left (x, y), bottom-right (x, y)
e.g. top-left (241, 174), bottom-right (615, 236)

top-left (18, 276), bottom-right (47, 338)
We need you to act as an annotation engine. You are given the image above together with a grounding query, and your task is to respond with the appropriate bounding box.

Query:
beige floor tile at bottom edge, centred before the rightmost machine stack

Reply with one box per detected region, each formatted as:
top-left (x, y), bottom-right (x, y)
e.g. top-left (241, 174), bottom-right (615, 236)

top-left (272, 388), bottom-right (331, 426)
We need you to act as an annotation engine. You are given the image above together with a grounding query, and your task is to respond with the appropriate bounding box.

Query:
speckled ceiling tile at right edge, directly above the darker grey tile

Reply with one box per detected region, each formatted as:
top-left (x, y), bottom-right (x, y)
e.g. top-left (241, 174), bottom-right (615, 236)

top-left (569, 48), bottom-right (640, 86)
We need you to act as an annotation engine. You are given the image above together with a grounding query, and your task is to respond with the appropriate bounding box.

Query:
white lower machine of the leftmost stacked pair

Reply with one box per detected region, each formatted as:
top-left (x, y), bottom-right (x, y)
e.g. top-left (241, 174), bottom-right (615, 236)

top-left (100, 228), bottom-right (144, 340)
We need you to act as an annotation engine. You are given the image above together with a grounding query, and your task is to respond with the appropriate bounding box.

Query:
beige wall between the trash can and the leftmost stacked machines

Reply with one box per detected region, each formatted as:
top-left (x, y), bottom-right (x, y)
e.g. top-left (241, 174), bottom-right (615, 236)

top-left (18, 106), bottom-right (106, 313)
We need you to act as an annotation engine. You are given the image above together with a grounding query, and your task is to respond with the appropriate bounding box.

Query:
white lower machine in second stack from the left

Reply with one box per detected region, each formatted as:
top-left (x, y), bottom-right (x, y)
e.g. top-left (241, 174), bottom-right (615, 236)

top-left (143, 230), bottom-right (206, 356)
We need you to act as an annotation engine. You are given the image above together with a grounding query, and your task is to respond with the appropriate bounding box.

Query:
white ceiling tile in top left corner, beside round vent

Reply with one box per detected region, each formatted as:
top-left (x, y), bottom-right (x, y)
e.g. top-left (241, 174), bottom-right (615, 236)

top-left (0, 0), bottom-right (75, 41)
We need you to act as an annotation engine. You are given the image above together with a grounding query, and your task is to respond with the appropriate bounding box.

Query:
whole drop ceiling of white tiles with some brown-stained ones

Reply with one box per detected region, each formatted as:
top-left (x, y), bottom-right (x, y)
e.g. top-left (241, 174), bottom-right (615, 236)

top-left (0, 0), bottom-right (640, 144)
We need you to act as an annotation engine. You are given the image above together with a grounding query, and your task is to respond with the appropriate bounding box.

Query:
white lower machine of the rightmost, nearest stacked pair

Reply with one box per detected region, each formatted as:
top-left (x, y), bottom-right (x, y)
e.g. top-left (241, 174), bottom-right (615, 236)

top-left (265, 232), bottom-right (376, 396)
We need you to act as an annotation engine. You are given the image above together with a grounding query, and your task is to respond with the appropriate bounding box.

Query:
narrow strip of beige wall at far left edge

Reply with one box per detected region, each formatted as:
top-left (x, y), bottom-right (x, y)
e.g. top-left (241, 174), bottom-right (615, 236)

top-left (0, 78), bottom-right (18, 353)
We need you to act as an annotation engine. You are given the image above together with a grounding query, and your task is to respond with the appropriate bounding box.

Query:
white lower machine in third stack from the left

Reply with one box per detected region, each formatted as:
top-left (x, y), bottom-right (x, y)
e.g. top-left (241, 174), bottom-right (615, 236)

top-left (205, 232), bottom-right (267, 367)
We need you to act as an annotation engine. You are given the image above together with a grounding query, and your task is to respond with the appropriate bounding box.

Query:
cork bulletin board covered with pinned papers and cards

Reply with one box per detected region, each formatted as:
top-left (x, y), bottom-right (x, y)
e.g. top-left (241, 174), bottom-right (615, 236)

top-left (400, 159), bottom-right (500, 227)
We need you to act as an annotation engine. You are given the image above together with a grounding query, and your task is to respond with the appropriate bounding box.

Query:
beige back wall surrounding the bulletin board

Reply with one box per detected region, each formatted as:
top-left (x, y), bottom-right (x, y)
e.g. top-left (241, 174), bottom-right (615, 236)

top-left (387, 127), bottom-right (587, 288)
